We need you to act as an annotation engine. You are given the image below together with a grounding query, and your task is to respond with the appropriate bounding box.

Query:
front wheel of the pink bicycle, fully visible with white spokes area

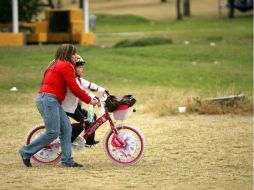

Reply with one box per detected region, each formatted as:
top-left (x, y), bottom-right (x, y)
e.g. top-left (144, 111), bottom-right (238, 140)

top-left (104, 124), bottom-right (145, 166)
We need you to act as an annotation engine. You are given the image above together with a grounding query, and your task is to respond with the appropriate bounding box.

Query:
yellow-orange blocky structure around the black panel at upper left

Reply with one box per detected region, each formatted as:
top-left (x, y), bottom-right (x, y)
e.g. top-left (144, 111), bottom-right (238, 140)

top-left (0, 9), bottom-right (94, 46)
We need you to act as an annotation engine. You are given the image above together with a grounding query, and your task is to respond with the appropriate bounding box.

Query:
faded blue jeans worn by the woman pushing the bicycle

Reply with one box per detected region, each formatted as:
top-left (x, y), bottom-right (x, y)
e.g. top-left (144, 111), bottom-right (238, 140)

top-left (20, 93), bottom-right (74, 165)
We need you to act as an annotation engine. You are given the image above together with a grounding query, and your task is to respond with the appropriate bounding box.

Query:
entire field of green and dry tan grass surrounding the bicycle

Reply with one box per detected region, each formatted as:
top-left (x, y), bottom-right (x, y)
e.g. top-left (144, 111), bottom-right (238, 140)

top-left (0, 0), bottom-right (253, 190)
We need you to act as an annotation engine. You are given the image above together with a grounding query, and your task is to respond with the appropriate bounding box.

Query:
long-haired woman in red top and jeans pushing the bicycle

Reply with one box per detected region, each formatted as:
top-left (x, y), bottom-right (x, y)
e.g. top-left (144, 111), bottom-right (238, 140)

top-left (19, 44), bottom-right (98, 167)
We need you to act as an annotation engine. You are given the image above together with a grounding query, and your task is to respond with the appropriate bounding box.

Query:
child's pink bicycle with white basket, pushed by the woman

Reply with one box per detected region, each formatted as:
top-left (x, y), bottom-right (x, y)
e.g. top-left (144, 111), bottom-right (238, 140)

top-left (25, 95), bottom-right (145, 166)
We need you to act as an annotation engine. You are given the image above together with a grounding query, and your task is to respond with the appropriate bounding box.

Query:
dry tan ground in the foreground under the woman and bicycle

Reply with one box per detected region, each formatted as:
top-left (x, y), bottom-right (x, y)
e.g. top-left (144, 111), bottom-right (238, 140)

top-left (0, 101), bottom-right (253, 190)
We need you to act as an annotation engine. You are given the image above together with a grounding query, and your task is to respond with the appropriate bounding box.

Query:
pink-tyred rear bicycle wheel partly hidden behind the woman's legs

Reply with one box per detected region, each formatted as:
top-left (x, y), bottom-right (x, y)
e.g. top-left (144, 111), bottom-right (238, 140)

top-left (25, 124), bottom-right (61, 164)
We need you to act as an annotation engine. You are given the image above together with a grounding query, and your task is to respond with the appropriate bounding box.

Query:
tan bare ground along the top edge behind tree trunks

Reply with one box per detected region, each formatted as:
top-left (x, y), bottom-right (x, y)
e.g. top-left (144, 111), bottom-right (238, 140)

top-left (62, 0), bottom-right (238, 20)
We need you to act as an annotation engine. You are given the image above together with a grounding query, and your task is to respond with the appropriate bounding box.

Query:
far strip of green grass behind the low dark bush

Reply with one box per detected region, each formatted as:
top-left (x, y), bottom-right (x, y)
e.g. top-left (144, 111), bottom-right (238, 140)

top-left (94, 16), bottom-right (253, 45)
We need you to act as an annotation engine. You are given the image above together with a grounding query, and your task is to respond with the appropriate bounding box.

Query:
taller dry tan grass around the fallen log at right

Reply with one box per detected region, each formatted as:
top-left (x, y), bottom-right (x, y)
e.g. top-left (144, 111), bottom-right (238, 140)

top-left (141, 88), bottom-right (253, 116)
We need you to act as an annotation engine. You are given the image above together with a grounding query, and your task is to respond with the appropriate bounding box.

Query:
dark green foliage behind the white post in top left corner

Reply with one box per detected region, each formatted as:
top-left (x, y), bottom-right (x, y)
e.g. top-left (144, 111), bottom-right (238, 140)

top-left (0, 0), bottom-right (39, 23)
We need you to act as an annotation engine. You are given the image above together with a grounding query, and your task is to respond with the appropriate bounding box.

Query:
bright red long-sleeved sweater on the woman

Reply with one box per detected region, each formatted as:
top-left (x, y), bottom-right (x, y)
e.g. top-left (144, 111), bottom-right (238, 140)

top-left (40, 60), bottom-right (91, 104)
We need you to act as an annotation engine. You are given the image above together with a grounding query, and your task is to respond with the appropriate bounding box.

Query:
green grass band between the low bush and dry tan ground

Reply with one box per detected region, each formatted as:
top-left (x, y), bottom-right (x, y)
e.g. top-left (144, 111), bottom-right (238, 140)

top-left (0, 42), bottom-right (252, 92)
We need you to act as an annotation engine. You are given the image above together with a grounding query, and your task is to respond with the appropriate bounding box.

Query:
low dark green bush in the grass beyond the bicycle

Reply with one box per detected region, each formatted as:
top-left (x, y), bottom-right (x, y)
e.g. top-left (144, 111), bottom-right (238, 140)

top-left (114, 37), bottom-right (172, 48)
